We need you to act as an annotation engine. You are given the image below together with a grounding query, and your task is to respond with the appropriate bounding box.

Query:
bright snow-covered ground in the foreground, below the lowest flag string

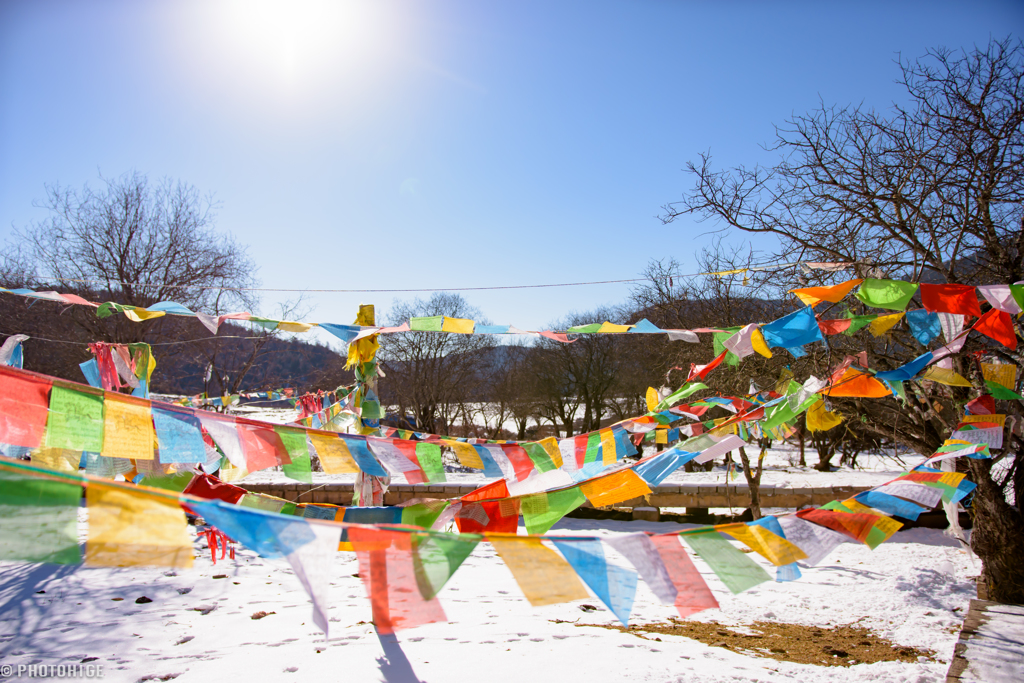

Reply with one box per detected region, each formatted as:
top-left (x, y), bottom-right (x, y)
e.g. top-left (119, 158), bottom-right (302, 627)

top-left (0, 510), bottom-right (978, 683)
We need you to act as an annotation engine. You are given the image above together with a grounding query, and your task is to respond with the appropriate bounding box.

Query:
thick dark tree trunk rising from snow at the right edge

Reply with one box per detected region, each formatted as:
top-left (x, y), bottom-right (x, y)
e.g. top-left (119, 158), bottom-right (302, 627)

top-left (969, 459), bottom-right (1024, 604)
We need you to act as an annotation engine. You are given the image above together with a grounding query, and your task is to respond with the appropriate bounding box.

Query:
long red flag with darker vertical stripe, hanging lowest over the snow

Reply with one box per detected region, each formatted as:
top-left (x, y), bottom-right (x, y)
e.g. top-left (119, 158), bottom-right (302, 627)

top-left (348, 528), bottom-right (447, 635)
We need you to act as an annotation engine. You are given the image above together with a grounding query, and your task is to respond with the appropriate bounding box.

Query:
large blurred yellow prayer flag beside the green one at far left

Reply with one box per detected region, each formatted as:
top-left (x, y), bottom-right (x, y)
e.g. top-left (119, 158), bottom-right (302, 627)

top-left (85, 484), bottom-right (193, 567)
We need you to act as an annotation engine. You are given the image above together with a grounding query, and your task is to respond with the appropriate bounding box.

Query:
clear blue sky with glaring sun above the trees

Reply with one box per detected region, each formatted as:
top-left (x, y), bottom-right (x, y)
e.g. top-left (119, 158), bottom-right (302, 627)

top-left (0, 0), bottom-right (1024, 342)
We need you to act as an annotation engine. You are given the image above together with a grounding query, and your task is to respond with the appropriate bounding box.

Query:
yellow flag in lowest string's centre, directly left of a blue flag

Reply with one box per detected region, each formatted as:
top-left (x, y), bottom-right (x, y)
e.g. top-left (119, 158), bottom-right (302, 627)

top-left (486, 533), bottom-right (590, 607)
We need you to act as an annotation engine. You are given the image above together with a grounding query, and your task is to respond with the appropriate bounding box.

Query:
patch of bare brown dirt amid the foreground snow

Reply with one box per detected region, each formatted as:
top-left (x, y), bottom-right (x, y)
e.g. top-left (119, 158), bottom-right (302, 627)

top-left (555, 618), bottom-right (935, 667)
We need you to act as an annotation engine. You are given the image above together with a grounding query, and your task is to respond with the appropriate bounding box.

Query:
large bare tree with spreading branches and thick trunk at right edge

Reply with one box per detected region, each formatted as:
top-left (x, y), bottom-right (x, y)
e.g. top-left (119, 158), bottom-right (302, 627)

top-left (664, 39), bottom-right (1024, 602)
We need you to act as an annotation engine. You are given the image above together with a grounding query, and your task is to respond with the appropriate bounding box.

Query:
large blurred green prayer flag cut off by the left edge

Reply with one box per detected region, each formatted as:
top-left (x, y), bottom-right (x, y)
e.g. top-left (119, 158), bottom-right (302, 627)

top-left (0, 470), bottom-right (82, 564)
